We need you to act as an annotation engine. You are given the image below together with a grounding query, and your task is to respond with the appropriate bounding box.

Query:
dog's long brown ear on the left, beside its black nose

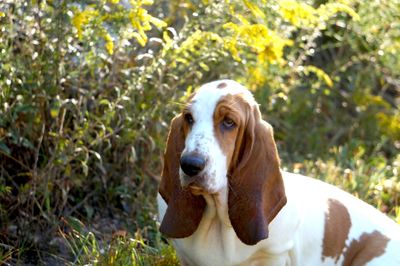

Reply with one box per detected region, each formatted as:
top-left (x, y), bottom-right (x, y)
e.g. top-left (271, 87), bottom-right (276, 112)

top-left (159, 115), bottom-right (206, 238)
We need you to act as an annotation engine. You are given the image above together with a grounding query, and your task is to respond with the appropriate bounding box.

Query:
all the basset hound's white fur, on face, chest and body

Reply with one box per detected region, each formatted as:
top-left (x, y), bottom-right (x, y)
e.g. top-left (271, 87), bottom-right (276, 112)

top-left (158, 80), bottom-right (400, 266)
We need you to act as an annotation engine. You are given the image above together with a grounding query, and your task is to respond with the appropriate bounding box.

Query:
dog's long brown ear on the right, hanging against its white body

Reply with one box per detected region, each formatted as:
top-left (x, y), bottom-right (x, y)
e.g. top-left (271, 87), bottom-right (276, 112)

top-left (228, 106), bottom-right (286, 245)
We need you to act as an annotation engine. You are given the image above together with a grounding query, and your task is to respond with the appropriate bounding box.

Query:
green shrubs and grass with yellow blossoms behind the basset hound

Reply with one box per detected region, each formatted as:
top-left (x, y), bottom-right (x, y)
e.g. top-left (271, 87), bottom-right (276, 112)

top-left (0, 0), bottom-right (400, 265)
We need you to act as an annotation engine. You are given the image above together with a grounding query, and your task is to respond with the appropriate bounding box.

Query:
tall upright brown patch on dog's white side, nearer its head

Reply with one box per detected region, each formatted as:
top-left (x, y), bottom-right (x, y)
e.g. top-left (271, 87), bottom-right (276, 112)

top-left (322, 199), bottom-right (351, 262)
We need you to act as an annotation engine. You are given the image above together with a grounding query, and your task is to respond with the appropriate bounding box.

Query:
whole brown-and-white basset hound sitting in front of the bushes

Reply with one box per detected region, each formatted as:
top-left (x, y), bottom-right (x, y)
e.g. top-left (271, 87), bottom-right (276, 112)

top-left (158, 80), bottom-right (400, 266)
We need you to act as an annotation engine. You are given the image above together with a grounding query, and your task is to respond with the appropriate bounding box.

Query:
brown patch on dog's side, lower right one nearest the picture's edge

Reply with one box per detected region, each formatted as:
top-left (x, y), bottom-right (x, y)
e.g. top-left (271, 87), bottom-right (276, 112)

top-left (343, 231), bottom-right (389, 266)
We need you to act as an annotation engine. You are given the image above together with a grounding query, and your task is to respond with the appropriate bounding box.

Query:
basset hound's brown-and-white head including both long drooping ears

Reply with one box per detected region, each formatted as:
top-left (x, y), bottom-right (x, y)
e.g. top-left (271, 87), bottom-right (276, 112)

top-left (160, 80), bottom-right (286, 245)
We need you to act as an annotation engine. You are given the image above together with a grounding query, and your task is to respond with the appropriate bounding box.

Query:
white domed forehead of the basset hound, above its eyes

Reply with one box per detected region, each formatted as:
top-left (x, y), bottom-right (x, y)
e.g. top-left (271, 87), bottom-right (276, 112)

top-left (191, 80), bottom-right (256, 118)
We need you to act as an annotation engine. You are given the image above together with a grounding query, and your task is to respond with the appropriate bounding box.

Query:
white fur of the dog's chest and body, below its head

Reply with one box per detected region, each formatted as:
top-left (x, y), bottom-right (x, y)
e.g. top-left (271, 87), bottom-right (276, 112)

top-left (158, 172), bottom-right (400, 266)
